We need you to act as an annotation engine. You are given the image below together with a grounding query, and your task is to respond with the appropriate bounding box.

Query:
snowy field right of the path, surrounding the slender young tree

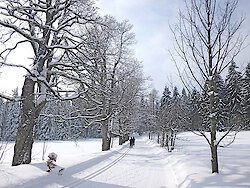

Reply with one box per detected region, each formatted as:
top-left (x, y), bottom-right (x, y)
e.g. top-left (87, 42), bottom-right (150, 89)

top-left (166, 131), bottom-right (250, 188)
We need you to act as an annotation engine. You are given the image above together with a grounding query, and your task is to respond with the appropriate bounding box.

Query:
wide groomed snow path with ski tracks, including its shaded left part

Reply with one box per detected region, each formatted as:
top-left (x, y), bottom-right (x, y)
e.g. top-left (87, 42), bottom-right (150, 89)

top-left (11, 138), bottom-right (177, 188)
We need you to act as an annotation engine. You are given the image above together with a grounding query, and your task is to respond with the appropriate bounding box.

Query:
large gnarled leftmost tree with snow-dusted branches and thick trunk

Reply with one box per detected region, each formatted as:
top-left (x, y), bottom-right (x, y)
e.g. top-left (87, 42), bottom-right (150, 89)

top-left (0, 0), bottom-right (96, 166)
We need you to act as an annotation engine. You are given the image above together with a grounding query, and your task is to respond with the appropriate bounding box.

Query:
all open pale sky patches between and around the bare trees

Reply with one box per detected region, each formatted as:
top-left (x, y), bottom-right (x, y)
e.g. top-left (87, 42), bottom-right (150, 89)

top-left (0, 0), bottom-right (250, 95)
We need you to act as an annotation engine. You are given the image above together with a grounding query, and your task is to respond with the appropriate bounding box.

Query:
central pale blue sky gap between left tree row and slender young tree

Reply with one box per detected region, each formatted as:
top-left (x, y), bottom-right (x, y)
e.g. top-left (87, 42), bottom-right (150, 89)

top-left (97, 0), bottom-right (183, 93)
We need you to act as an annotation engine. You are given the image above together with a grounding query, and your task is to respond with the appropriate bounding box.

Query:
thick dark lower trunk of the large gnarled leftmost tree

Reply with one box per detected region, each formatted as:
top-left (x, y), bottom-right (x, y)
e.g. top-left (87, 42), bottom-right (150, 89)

top-left (12, 77), bottom-right (45, 166)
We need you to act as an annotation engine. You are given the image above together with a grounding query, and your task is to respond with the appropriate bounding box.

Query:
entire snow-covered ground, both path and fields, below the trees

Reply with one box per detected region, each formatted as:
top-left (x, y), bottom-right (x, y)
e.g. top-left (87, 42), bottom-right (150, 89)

top-left (0, 132), bottom-right (250, 188)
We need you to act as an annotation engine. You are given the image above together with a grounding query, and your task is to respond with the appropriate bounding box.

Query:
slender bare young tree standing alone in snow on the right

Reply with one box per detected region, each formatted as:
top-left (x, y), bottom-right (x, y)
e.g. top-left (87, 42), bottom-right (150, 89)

top-left (173, 0), bottom-right (244, 173)
